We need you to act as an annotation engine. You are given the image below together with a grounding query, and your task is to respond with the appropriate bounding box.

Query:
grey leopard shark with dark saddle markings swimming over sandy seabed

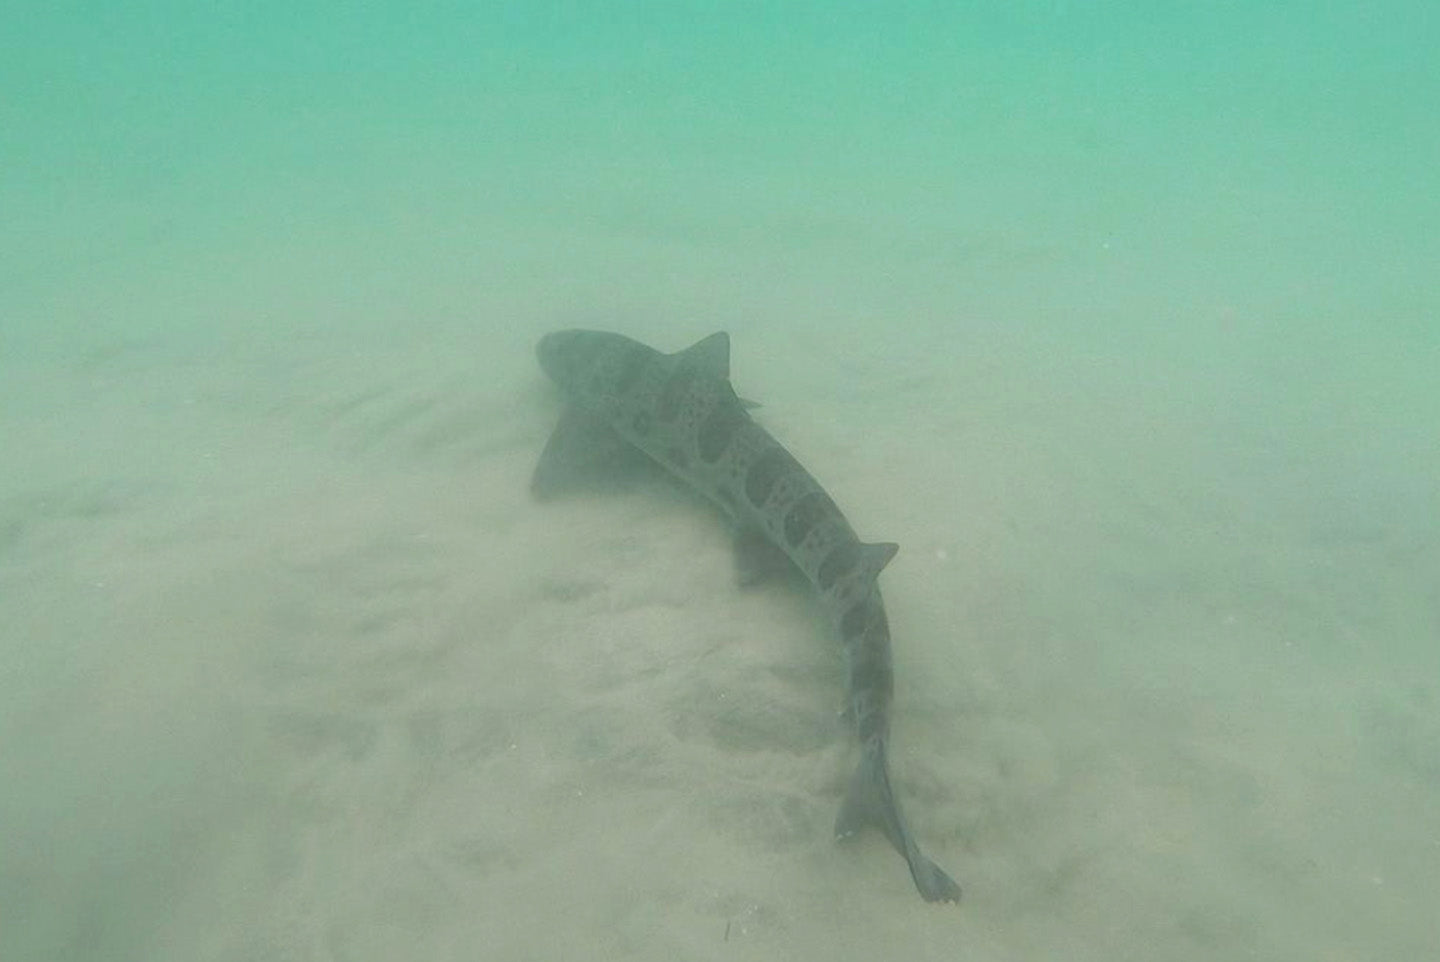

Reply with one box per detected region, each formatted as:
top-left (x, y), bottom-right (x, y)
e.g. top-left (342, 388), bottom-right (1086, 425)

top-left (531, 330), bottom-right (960, 902)
